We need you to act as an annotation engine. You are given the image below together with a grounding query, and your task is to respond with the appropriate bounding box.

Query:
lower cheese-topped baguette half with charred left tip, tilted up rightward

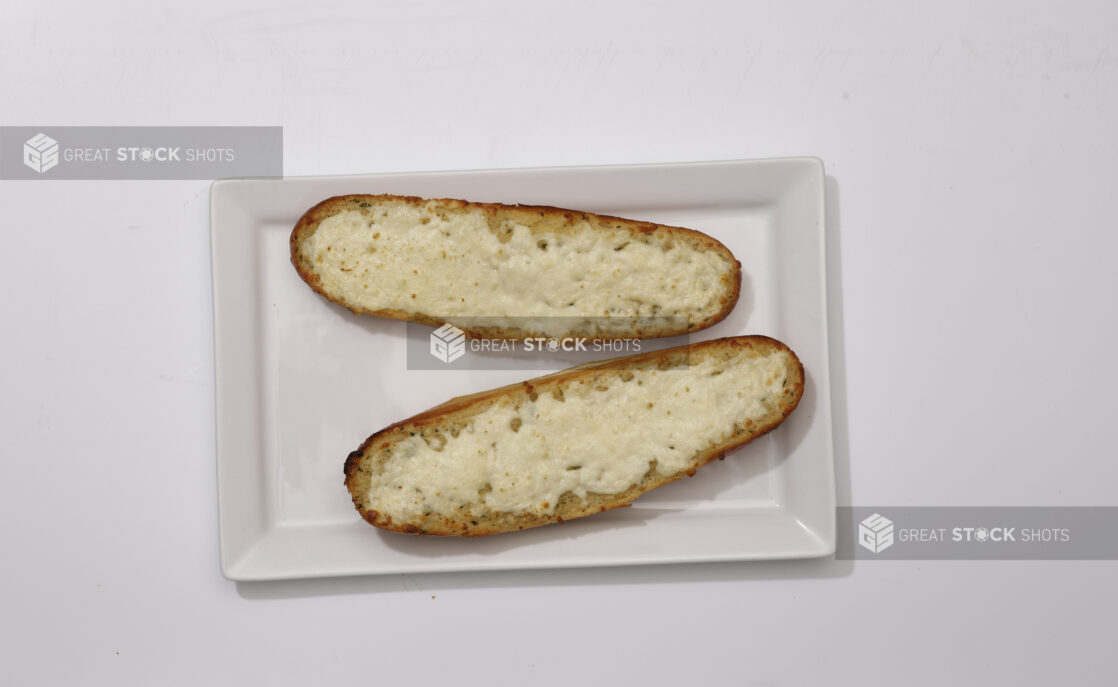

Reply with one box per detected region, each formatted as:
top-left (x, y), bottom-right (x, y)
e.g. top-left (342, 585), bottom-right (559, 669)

top-left (345, 337), bottom-right (804, 536)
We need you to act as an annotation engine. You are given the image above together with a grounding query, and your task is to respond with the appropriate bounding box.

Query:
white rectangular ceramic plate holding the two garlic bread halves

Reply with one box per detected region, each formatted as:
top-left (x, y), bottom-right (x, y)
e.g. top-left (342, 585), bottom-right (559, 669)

top-left (210, 159), bottom-right (835, 581)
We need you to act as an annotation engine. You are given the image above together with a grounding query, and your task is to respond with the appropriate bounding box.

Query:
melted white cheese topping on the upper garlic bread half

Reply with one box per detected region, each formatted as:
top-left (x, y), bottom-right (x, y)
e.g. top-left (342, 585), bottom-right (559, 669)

top-left (306, 203), bottom-right (732, 328)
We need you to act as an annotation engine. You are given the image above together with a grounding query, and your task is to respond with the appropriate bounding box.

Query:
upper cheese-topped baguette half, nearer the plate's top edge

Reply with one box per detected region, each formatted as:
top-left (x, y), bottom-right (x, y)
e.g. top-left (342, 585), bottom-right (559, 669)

top-left (291, 195), bottom-right (741, 339)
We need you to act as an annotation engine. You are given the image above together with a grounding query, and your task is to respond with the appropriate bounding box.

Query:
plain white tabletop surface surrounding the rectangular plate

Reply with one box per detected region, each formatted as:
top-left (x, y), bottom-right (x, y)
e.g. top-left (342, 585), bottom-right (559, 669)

top-left (0, 0), bottom-right (1118, 685)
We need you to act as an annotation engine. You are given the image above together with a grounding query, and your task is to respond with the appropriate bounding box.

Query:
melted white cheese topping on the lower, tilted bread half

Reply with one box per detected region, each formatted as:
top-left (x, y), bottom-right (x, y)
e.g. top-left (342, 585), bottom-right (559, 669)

top-left (368, 352), bottom-right (787, 517)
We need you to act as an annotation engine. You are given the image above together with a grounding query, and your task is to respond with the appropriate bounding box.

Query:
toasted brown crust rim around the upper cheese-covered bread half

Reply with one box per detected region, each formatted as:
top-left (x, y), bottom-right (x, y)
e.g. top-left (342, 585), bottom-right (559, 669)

top-left (290, 194), bottom-right (741, 340)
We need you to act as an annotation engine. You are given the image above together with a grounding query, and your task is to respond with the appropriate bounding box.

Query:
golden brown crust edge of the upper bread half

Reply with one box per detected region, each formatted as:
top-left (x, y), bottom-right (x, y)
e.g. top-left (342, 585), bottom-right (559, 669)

top-left (290, 194), bottom-right (741, 339)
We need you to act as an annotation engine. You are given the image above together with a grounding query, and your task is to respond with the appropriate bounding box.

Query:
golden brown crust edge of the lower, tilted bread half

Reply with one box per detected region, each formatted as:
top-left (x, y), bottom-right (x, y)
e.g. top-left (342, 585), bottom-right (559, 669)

top-left (344, 336), bottom-right (804, 537)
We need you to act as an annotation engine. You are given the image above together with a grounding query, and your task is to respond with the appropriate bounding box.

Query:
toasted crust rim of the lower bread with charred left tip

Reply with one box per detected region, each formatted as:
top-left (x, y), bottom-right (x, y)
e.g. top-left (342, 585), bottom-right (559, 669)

top-left (344, 336), bottom-right (804, 537)
